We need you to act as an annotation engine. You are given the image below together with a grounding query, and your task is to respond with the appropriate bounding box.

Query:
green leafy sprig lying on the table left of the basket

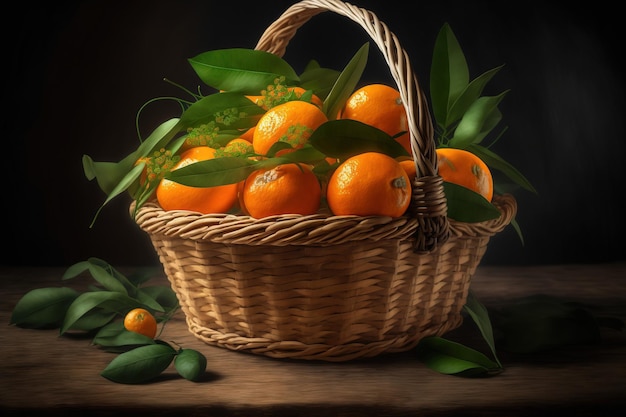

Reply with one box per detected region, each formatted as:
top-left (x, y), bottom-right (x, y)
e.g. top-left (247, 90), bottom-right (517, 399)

top-left (10, 258), bottom-right (206, 384)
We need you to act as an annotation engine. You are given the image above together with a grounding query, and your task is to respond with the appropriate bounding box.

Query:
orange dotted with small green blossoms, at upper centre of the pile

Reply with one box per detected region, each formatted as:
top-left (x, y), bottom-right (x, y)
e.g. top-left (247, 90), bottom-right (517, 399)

top-left (252, 101), bottom-right (328, 155)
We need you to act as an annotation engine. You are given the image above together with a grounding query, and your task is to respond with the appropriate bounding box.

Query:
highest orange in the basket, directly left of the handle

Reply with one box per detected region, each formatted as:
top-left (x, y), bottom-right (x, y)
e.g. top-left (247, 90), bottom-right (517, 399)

top-left (340, 84), bottom-right (413, 155)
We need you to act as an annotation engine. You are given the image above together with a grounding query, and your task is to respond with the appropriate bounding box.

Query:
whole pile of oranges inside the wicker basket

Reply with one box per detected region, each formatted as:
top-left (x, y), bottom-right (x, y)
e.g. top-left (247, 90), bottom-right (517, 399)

top-left (143, 79), bottom-right (493, 218)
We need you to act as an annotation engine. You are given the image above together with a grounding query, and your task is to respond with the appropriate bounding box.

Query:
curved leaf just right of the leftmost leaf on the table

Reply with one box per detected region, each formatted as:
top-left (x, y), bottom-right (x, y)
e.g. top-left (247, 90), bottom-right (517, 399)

top-left (61, 291), bottom-right (138, 334)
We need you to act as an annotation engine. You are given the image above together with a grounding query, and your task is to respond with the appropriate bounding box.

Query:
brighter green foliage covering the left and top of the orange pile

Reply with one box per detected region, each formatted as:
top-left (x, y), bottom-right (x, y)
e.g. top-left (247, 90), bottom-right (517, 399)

top-left (83, 43), bottom-right (368, 224)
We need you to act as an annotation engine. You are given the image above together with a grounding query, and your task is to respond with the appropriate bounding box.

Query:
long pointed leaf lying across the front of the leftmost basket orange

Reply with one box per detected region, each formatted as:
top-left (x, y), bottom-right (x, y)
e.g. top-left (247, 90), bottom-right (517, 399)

top-left (165, 157), bottom-right (257, 187)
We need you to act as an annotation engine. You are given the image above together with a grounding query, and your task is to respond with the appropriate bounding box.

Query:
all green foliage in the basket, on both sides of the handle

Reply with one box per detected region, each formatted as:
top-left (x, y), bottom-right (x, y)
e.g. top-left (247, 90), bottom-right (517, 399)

top-left (83, 24), bottom-right (534, 229)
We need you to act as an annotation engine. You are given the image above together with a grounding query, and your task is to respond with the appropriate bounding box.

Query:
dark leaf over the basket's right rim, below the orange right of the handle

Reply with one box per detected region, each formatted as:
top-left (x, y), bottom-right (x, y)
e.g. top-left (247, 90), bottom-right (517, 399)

top-left (443, 181), bottom-right (502, 223)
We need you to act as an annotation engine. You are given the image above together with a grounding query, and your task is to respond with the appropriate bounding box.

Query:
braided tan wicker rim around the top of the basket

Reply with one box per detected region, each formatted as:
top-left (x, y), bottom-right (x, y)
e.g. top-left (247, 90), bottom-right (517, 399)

top-left (130, 194), bottom-right (517, 245)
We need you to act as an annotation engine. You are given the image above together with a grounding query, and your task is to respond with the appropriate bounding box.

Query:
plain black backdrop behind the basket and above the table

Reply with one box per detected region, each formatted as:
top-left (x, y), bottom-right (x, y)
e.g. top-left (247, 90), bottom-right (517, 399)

top-left (1, 0), bottom-right (626, 266)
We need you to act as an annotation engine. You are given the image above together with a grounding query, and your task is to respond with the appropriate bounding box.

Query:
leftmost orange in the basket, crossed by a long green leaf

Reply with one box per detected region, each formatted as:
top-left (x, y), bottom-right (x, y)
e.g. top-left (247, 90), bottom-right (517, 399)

top-left (156, 146), bottom-right (237, 214)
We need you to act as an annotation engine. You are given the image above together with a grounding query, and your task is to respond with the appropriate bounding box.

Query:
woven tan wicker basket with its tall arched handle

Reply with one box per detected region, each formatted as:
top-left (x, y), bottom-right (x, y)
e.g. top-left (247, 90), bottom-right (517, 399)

top-left (130, 0), bottom-right (516, 361)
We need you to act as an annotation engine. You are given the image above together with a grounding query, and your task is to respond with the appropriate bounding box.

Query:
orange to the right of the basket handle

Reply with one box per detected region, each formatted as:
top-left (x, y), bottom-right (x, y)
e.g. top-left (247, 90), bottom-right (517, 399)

top-left (436, 148), bottom-right (493, 201)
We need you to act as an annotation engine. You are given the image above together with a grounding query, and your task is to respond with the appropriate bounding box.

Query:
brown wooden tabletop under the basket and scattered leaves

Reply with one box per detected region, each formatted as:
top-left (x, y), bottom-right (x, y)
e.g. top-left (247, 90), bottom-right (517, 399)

top-left (0, 263), bottom-right (626, 417)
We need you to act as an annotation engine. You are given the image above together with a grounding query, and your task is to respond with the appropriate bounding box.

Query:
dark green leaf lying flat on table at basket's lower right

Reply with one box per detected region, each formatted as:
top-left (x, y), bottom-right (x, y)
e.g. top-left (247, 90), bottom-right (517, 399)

top-left (416, 336), bottom-right (502, 377)
